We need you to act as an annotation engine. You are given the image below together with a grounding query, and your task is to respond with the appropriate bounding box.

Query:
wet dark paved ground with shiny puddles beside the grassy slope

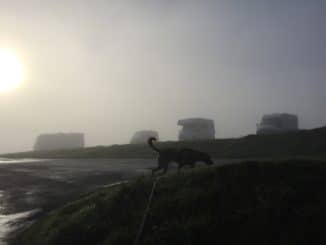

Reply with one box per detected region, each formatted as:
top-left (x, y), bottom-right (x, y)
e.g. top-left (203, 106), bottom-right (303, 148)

top-left (0, 159), bottom-right (155, 245)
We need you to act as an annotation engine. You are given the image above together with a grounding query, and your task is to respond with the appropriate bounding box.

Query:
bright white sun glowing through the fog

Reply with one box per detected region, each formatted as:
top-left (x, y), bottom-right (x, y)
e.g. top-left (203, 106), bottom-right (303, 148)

top-left (0, 48), bottom-right (24, 93)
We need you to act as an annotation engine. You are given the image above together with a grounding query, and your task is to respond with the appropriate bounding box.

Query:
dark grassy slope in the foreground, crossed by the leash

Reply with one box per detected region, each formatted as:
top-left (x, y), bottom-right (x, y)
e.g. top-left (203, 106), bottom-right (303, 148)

top-left (17, 160), bottom-right (326, 245)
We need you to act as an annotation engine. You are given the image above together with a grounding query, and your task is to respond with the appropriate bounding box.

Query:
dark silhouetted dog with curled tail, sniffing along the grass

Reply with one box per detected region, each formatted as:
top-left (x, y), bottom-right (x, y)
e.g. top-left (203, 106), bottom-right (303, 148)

top-left (148, 137), bottom-right (213, 174)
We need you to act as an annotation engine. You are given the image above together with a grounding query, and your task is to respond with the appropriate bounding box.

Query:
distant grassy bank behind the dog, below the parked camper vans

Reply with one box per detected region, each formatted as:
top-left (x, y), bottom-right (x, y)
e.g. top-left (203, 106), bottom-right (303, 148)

top-left (1, 127), bottom-right (326, 158)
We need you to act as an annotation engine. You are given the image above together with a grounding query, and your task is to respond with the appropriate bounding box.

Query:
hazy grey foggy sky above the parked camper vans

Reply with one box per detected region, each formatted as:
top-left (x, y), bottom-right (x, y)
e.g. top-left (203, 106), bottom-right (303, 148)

top-left (0, 0), bottom-right (326, 152)
